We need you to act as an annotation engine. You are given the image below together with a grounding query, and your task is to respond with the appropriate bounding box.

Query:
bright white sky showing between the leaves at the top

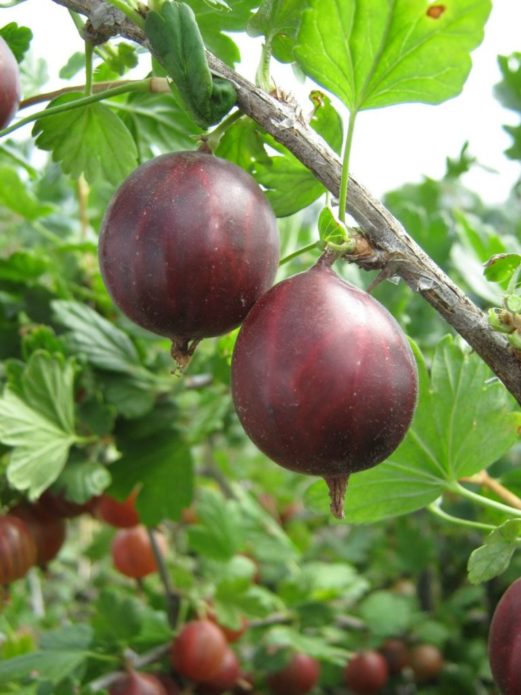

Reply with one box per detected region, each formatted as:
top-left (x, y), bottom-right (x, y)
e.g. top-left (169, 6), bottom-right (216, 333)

top-left (4, 0), bottom-right (521, 202)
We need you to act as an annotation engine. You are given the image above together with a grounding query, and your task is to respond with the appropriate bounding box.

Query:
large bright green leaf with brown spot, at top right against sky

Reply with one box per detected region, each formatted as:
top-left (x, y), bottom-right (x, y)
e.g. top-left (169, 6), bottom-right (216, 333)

top-left (295, 0), bottom-right (491, 112)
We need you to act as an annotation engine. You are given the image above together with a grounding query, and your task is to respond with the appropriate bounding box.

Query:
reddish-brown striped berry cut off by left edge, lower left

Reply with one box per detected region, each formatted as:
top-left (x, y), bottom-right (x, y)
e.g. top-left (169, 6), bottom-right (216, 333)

top-left (0, 515), bottom-right (36, 585)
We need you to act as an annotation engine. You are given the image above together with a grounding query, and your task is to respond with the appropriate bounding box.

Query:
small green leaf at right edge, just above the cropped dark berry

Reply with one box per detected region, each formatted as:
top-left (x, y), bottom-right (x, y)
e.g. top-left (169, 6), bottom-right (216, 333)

top-left (467, 519), bottom-right (521, 584)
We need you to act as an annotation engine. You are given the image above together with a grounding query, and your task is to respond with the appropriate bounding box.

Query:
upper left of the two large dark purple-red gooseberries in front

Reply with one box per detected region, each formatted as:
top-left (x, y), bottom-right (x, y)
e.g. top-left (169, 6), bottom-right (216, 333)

top-left (99, 152), bottom-right (279, 364)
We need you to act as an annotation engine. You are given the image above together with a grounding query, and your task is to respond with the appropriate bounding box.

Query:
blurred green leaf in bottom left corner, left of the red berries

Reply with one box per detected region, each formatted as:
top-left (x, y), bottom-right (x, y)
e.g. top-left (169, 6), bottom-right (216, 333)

top-left (0, 625), bottom-right (91, 685)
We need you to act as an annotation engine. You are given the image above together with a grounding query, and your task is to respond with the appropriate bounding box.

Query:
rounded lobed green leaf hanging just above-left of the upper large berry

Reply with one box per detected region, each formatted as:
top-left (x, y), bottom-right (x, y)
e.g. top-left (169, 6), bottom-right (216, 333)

top-left (33, 93), bottom-right (137, 186)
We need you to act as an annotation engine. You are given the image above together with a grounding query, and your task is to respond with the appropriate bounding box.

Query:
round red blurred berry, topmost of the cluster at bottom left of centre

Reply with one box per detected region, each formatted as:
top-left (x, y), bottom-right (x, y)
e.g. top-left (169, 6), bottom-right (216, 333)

top-left (171, 620), bottom-right (229, 683)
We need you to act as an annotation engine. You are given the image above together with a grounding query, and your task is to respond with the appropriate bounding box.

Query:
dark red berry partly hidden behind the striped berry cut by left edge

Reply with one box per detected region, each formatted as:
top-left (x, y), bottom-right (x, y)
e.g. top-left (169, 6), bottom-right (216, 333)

top-left (10, 503), bottom-right (67, 567)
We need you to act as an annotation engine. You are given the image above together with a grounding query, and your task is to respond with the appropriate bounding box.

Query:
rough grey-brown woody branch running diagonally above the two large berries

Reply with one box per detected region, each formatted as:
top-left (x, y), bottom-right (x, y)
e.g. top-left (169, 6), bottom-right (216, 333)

top-left (48, 0), bottom-right (521, 403)
